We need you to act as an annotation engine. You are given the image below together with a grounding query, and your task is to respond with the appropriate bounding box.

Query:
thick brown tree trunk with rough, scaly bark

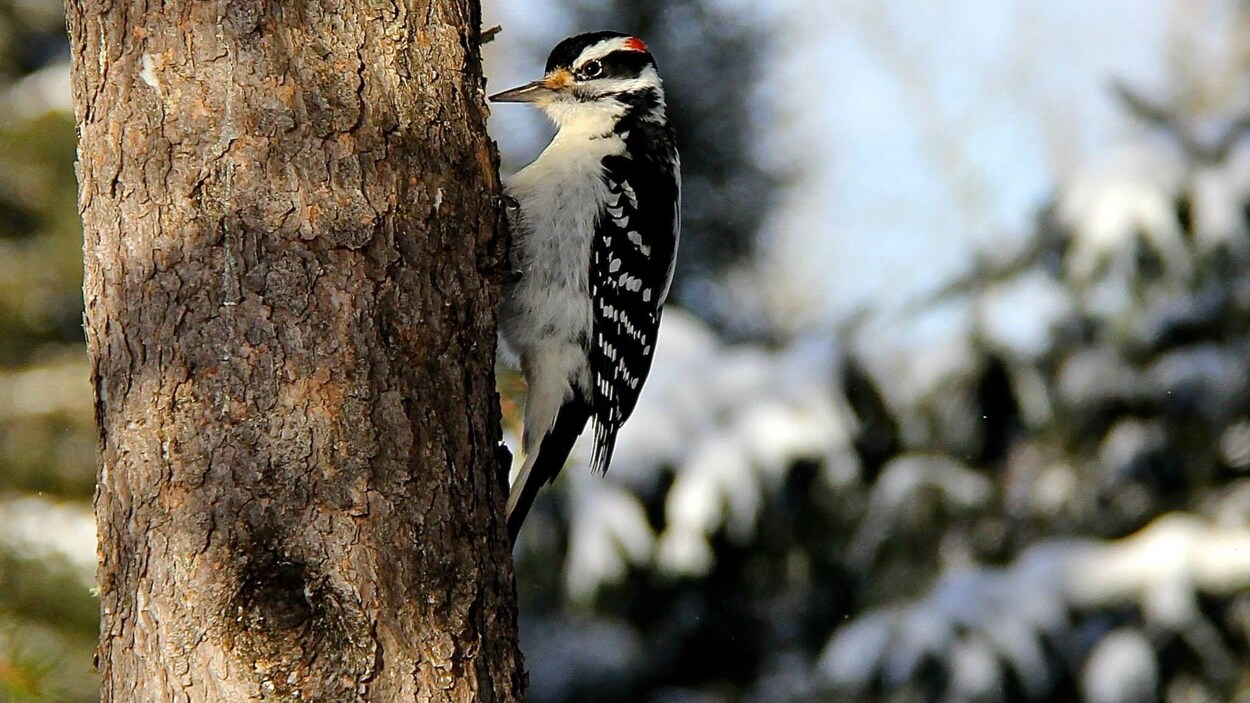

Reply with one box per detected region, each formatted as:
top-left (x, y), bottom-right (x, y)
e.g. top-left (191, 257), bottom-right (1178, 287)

top-left (68, 0), bottom-right (521, 703)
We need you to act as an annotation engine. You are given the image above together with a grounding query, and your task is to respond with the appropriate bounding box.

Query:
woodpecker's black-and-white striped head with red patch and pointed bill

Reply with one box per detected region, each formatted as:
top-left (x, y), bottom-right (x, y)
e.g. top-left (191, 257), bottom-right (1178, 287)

top-left (490, 31), bottom-right (664, 126)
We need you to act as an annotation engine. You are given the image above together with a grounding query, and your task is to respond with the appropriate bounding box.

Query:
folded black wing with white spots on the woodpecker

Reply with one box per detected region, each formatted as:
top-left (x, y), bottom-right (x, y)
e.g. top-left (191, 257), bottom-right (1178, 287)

top-left (590, 150), bottom-right (680, 473)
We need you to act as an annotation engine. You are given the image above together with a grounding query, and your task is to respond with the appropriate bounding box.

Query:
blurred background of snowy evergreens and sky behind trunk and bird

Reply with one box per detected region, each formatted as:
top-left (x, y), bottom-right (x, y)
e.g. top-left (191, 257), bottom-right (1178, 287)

top-left (0, 0), bottom-right (1250, 703)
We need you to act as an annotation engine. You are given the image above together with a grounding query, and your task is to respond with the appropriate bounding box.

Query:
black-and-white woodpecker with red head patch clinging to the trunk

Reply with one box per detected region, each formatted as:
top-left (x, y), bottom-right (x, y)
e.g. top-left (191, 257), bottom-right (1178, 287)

top-left (491, 31), bottom-right (681, 543)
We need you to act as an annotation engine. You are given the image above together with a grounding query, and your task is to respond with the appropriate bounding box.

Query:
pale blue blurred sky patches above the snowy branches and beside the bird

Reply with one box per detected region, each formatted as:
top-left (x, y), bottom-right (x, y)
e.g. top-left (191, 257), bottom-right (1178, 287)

top-left (486, 0), bottom-right (1245, 329)
